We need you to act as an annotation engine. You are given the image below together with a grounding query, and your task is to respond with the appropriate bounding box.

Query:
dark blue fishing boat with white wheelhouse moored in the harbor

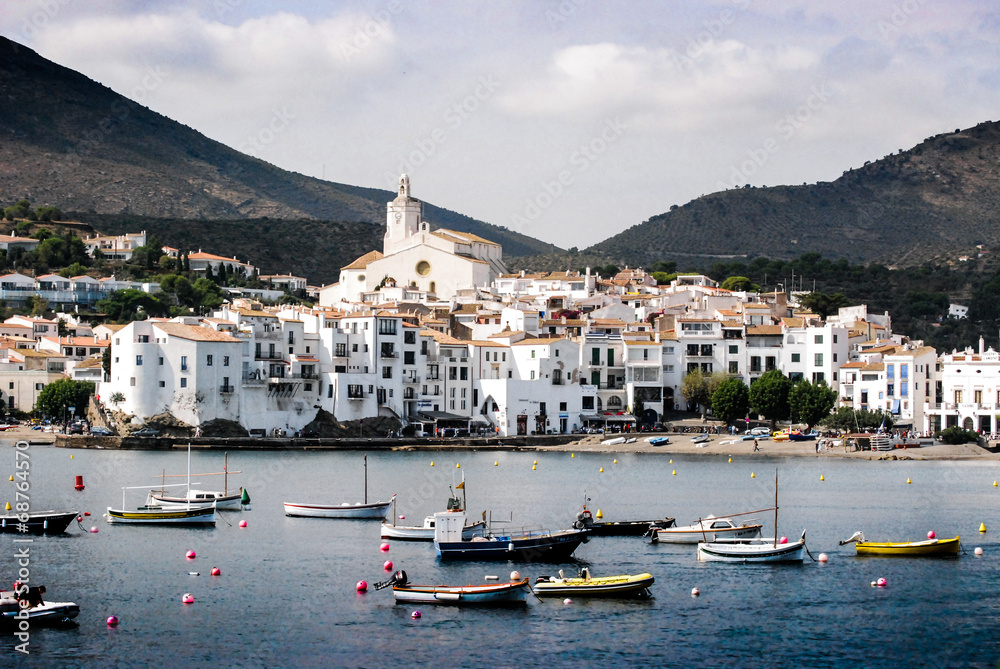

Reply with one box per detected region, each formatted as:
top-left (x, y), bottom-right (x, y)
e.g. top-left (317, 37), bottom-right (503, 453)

top-left (434, 512), bottom-right (590, 562)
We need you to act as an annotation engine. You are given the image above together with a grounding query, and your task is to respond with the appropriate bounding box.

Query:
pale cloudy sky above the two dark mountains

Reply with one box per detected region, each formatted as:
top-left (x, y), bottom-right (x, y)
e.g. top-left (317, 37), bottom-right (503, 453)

top-left (0, 0), bottom-right (1000, 249)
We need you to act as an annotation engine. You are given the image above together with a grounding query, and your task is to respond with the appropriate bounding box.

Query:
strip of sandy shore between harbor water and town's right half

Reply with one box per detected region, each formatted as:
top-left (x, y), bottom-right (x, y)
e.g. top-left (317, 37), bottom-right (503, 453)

top-left (545, 433), bottom-right (1000, 461)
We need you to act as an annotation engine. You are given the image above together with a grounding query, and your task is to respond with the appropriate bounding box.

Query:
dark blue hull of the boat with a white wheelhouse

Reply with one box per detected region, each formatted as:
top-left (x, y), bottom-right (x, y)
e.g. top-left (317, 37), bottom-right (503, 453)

top-left (434, 530), bottom-right (589, 562)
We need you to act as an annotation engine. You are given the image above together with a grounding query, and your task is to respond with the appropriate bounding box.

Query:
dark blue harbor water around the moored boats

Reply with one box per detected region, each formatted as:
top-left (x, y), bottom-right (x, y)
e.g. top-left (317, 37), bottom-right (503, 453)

top-left (0, 444), bottom-right (1000, 668)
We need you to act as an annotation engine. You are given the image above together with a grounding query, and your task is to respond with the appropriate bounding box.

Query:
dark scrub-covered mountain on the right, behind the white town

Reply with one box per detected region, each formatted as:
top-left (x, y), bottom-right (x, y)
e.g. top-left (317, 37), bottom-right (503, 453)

top-left (585, 122), bottom-right (1000, 266)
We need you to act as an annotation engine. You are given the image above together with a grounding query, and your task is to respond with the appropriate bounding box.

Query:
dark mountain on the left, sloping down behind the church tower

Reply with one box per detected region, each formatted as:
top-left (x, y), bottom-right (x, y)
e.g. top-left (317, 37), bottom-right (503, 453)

top-left (0, 37), bottom-right (558, 280)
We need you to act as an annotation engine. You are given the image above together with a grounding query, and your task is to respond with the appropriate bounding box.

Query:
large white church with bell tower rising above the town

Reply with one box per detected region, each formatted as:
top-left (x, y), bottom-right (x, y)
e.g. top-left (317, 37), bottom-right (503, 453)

top-left (319, 174), bottom-right (507, 306)
